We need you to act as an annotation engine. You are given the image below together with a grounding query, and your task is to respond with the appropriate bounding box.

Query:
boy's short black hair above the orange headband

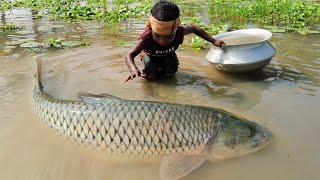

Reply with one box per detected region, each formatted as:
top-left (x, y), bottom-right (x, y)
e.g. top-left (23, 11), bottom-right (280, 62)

top-left (151, 0), bottom-right (180, 21)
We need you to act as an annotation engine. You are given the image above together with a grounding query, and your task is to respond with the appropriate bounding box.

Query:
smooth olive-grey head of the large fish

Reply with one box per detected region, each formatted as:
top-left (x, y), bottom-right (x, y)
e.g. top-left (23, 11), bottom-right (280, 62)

top-left (211, 112), bottom-right (272, 159)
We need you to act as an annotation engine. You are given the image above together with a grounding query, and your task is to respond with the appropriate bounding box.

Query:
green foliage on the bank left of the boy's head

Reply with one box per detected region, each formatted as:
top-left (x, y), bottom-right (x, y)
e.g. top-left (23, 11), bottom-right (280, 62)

top-left (0, 0), bottom-right (151, 22)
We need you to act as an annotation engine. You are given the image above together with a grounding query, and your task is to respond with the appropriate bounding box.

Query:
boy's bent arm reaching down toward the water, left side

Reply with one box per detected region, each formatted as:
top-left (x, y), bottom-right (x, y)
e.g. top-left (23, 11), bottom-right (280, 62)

top-left (125, 39), bottom-right (144, 81)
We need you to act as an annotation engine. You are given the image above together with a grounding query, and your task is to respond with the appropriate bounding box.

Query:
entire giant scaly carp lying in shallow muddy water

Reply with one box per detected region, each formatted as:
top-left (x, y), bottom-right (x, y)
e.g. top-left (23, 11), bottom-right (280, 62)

top-left (33, 59), bottom-right (271, 179)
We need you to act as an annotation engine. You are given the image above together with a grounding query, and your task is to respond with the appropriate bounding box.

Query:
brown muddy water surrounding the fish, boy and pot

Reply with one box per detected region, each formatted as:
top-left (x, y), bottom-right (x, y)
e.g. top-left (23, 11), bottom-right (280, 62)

top-left (0, 10), bottom-right (320, 180)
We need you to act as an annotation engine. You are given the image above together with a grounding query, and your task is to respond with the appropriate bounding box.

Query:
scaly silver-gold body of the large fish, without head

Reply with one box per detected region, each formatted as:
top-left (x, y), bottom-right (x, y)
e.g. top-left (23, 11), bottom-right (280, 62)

top-left (33, 91), bottom-right (218, 156)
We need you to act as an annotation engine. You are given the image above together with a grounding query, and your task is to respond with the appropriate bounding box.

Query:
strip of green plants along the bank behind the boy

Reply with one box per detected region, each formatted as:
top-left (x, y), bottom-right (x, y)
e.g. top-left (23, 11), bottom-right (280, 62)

top-left (0, 0), bottom-right (320, 48)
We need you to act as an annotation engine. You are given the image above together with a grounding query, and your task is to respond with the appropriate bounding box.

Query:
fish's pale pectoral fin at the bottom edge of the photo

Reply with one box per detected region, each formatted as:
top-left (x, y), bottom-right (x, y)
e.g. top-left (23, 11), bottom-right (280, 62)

top-left (159, 153), bottom-right (207, 180)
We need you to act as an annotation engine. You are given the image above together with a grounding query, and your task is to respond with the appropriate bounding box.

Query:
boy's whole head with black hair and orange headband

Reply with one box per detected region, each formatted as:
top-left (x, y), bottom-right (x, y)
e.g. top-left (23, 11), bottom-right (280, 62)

top-left (149, 0), bottom-right (180, 46)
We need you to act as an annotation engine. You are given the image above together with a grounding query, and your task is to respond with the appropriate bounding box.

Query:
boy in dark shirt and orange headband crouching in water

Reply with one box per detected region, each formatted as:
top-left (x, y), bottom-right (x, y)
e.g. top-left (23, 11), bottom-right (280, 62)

top-left (125, 0), bottom-right (224, 82)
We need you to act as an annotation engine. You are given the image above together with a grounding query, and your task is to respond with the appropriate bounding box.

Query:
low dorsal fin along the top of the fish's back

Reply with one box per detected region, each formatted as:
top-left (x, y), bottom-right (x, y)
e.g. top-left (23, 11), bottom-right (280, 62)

top-left (78, 92), bottom-right (123, 104)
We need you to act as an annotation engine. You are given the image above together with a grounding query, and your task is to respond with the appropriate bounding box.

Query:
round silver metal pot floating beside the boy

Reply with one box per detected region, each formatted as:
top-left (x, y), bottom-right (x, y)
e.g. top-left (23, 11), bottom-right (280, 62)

top-left (206, 29), bottom-right (276, 72)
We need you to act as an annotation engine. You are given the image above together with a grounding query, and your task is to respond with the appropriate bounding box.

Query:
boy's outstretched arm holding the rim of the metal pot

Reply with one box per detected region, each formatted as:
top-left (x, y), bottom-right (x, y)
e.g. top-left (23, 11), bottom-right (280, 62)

top-left (184, 25), bottom-right (225, 47)
